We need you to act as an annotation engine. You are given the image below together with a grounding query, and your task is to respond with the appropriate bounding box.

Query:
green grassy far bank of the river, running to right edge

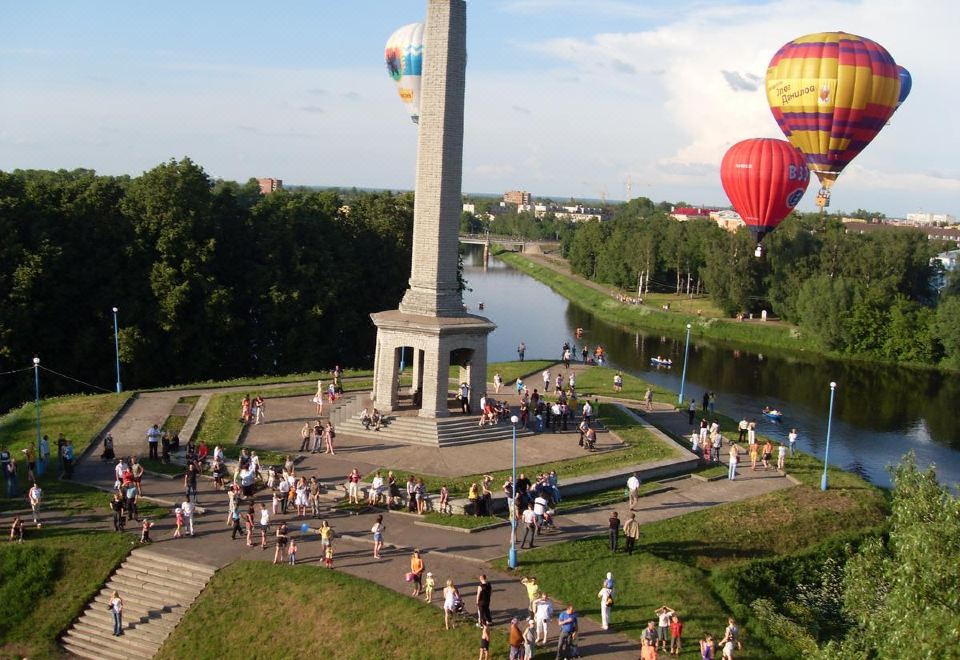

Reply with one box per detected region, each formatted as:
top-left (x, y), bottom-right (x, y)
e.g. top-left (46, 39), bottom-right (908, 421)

top-left (495, 250), bottom-right (956, 373)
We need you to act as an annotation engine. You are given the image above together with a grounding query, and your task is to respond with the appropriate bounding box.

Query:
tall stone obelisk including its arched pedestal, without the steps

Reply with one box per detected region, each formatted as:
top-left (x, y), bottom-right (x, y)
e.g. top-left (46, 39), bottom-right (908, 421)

top-left (371, 0), bottom-right (496, 418)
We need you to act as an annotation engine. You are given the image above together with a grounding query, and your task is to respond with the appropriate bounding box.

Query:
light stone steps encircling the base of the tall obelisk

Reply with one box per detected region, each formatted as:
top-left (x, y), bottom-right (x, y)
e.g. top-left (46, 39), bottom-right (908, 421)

top-left (337, 414), bottom-right (533, 447)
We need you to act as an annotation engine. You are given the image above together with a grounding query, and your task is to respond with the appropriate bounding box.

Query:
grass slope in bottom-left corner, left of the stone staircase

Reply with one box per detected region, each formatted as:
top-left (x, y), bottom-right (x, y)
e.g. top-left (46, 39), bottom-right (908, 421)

top-left (0, 528), bottom-right (134, 658)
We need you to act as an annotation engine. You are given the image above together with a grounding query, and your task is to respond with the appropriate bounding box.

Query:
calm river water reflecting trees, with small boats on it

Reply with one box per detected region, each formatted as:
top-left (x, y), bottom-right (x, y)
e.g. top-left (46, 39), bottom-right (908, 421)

top-left (464, 246), bottom-right (960, 487)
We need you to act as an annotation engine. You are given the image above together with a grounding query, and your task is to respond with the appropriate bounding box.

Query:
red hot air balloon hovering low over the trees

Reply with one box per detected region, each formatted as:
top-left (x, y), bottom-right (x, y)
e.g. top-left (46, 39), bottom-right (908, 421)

top-left (720, 138), bottom-right (810, 257)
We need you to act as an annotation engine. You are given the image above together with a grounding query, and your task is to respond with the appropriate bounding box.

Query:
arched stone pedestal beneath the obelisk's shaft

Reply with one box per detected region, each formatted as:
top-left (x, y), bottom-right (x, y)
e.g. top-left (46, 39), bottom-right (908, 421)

top-left (371, 310), bottom-right (497, 418)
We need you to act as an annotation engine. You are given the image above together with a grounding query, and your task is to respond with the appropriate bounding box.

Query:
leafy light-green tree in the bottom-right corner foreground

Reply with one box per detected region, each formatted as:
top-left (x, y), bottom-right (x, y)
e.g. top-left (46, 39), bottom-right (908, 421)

top-left (820, 453), bottom-right (960, 660)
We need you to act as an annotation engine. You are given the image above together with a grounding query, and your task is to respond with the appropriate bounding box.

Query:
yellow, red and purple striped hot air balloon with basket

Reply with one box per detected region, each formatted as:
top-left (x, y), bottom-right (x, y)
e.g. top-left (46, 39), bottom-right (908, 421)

top-left (767, 32), bottom-right (900, 207)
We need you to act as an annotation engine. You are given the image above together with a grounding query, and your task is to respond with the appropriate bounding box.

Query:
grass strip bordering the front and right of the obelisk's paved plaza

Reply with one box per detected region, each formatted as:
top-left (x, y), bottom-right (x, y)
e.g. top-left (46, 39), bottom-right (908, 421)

top-left (366, 404), bottom-right (675, 497)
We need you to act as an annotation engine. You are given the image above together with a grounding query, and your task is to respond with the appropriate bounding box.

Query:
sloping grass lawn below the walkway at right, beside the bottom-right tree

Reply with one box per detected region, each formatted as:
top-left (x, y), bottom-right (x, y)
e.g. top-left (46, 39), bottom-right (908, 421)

top-left (492, 448), bottom-right (888, 658)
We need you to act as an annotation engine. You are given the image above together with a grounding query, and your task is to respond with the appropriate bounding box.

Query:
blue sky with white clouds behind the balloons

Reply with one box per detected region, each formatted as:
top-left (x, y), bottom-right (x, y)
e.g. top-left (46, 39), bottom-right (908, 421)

top-left (0, 0), bottom-right (960, 217)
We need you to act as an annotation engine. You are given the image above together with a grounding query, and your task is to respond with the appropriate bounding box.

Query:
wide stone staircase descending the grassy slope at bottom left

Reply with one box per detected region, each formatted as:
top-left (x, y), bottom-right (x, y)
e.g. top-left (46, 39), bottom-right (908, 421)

top-left (60, 549), bottom-right (217, 660)
